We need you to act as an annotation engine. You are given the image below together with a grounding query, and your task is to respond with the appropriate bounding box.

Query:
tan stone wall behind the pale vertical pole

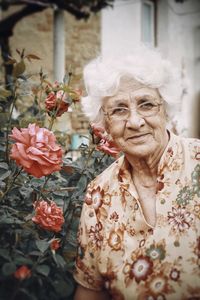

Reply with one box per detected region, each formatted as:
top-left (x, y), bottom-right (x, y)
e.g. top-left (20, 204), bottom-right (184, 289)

top-left (2, 8), bottom-right (100, 79)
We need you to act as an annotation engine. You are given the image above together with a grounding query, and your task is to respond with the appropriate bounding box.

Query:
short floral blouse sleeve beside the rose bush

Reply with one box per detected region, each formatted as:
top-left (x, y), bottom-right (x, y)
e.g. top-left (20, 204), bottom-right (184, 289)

top-left (73, 194), bottom-right (104, 291)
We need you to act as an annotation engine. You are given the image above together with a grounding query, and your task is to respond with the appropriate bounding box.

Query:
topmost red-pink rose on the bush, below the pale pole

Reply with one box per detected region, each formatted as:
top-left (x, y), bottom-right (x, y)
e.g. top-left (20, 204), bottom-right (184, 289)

top-left (45, 90), bottom-right (69, 117)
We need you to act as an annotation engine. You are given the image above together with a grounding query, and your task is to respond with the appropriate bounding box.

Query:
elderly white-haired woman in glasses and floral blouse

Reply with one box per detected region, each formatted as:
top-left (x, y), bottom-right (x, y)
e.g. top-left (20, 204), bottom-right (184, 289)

top-left (74, 49), bottom-right (200, 300)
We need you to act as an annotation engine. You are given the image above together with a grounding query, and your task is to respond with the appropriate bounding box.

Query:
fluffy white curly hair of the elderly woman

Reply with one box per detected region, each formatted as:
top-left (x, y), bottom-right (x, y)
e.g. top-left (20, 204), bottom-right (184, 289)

top-left (81, 46), bottom-right (183, 124)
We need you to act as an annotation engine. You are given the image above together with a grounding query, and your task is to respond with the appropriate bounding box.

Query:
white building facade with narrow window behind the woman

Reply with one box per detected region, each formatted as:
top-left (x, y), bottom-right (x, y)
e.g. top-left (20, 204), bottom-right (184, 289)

top-left (101, 0), bottom-right (200, 138)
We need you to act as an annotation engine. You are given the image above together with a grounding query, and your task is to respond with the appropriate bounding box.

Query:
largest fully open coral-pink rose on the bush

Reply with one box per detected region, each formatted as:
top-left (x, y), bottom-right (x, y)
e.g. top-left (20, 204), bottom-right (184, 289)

top-left (10, 124), bottom-right (62, 178)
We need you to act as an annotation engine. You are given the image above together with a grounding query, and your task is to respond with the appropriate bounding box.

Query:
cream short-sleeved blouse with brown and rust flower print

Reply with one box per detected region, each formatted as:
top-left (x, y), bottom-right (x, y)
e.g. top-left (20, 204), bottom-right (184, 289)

top-left (74, 133), bottom-right (200, 300)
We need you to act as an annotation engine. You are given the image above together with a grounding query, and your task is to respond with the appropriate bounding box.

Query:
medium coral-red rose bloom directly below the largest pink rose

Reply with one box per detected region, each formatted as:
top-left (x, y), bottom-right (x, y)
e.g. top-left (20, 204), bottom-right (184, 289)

top-left (32, 200), bottom-right (64, 232)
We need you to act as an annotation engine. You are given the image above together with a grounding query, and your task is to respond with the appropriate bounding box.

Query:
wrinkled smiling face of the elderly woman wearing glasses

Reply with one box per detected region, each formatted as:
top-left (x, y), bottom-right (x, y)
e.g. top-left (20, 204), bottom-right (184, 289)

top-left (102, 79), bottom-right (168, 158)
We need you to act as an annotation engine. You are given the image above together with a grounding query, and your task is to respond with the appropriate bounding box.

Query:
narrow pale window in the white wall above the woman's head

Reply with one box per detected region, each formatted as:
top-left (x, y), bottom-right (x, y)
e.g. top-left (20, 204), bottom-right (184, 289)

top-left (142, 0), bottom-right (156, 46)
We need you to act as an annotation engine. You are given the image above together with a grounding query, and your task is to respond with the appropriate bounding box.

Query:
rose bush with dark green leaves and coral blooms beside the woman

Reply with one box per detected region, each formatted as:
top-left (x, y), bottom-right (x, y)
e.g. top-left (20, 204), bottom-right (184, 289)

top-left (0, 50), bottom-right (112, 300)
